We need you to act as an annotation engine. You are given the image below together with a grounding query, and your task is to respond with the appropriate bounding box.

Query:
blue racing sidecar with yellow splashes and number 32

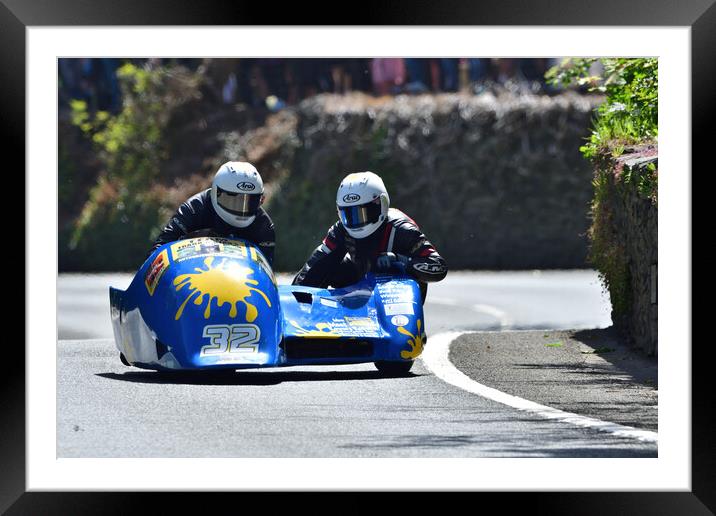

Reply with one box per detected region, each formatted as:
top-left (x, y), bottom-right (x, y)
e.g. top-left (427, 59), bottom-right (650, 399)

top-left (109, 237), bottom-right (426, 370)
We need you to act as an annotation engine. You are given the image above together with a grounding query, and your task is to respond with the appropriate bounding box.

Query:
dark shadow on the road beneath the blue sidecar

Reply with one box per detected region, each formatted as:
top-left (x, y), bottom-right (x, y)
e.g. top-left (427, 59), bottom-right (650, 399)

top-left (96, 371), bottom-right (421, 385)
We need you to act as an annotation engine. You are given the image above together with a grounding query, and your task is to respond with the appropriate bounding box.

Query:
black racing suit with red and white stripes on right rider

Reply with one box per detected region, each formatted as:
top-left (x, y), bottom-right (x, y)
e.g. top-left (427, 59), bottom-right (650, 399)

top-left (293, 208), bottom-right (447, 302)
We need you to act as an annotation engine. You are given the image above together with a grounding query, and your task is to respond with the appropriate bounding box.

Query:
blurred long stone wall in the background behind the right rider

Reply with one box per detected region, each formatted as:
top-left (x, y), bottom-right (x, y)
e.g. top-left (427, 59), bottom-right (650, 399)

top-left (268, 92), bottom-right (602, 270)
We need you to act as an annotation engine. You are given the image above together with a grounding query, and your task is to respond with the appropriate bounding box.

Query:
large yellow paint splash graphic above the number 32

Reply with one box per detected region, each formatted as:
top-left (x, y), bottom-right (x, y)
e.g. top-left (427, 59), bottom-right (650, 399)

top-left (174, 256), bottom-right (271, 322)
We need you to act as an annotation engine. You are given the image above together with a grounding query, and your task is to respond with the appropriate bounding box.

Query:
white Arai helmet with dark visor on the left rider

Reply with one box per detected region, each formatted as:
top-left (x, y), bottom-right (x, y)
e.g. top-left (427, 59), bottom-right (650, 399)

top-left (211, 161), bottom-right (264, 228)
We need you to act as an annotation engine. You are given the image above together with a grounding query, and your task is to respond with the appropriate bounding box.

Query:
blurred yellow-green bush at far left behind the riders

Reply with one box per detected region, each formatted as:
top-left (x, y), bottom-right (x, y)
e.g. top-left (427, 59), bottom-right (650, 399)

top-left (64, 63), bottom-right (202, 269)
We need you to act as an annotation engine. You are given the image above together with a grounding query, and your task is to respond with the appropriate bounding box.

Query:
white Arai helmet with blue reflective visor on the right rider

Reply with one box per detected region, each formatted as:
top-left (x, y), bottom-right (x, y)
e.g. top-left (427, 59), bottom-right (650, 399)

top-left (336, 172), bottom-right (390, 238)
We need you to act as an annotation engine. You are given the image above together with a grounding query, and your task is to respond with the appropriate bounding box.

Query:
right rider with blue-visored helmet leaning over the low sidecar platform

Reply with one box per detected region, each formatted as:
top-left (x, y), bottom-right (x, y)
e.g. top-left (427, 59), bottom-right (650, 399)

top-left (293, 172), bottom-right (447, 302)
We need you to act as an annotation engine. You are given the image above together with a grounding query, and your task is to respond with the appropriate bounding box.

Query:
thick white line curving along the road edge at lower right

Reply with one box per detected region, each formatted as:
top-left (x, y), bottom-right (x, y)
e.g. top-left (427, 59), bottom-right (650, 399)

top-left (420, 332), bottom-right (658, 443)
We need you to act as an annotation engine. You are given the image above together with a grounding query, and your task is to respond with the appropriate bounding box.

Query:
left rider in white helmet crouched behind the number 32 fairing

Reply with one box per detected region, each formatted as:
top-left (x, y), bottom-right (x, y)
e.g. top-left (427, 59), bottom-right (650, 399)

top-left (150, 161), bottom-right (276, 264)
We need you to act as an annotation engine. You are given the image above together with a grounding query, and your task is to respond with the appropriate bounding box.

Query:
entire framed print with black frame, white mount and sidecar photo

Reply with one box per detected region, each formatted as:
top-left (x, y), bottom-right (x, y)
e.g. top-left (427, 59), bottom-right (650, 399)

top-left (7, 0), bottom-right (716, 514)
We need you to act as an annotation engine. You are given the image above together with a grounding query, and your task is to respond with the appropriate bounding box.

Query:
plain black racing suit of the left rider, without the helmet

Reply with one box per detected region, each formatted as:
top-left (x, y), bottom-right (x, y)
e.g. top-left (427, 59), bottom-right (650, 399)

top-left (150, 188), bottom-right (276, 265)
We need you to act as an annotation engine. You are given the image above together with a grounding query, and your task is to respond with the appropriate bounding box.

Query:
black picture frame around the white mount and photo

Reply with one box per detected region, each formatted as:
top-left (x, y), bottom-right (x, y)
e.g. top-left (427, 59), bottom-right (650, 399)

top-left (7, 0), bottom-right (716, 514)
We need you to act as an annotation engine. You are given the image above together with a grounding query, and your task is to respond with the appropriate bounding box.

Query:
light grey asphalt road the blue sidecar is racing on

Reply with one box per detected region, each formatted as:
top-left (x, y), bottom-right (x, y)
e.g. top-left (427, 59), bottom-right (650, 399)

top-left (57, 271), bottom-right (657, 457)
